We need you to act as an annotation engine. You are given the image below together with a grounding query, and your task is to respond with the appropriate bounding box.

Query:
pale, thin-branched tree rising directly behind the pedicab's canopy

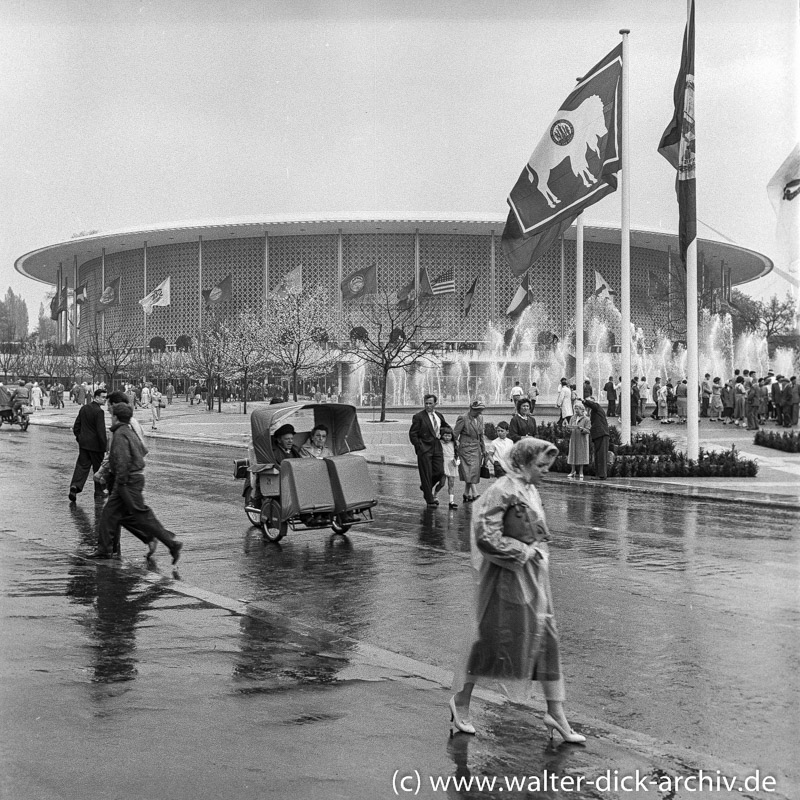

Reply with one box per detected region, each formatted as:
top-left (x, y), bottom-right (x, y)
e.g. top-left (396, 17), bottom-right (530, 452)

top-left (262, 287), bottom-right (344, 400)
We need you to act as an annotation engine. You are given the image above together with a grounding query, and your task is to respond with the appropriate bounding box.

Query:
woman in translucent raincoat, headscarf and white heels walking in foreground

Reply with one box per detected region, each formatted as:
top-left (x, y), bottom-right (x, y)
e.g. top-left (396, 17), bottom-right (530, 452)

top-left (450, 437), bottom-right (586, 744)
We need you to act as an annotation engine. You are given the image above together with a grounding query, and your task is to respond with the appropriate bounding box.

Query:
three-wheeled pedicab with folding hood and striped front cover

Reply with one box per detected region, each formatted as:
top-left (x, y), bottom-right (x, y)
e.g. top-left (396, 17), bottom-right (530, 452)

top-left (234, 402), bottom-right (378, 542)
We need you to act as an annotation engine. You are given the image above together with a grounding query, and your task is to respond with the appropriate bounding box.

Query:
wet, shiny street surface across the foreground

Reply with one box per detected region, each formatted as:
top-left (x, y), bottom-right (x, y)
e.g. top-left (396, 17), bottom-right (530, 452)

top-left (0, 409), bottom-right (800, 798)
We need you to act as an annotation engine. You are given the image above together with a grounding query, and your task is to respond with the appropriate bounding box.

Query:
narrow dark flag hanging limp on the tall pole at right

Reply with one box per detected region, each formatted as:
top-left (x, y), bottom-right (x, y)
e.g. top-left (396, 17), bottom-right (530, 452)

top-left (658, 2), bottom-right (697, 267)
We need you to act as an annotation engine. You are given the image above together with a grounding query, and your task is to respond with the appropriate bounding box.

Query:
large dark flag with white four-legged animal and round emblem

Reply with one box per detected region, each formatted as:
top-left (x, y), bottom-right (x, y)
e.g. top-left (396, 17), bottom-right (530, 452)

top-left (503, 44), bottom-right (622, 275)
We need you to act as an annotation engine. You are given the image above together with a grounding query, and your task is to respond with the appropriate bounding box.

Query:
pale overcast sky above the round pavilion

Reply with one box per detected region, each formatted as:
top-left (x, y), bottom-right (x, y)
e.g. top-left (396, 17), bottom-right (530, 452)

top-left (0, 0), bottom-right (800, 332)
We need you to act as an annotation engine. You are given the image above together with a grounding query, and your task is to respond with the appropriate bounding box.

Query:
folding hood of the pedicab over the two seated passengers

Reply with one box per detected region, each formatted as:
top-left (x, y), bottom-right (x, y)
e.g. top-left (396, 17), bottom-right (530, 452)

top-left (250, 403), bottom-right (365, 464)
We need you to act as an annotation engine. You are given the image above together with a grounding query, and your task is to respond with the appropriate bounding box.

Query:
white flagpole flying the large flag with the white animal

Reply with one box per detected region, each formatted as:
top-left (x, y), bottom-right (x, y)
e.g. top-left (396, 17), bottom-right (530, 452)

top-left (620, 28), bottom-right (631, 444)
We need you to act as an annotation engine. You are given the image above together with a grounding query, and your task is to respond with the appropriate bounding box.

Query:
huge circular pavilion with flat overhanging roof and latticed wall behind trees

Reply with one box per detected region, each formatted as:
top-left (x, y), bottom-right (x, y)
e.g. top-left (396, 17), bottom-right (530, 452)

top-left (15, 215), bottom-right (772, 349)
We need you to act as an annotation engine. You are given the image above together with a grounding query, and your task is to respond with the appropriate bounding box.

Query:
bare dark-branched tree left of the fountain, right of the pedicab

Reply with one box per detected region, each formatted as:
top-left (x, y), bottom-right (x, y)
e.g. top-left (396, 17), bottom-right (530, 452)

top-left (347, 290), bottom-right (442, 422)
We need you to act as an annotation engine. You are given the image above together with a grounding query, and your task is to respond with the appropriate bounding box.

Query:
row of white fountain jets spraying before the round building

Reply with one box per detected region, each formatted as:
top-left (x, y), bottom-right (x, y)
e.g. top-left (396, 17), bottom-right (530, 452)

top-left (342, 296), bottom-right (800, 407)
